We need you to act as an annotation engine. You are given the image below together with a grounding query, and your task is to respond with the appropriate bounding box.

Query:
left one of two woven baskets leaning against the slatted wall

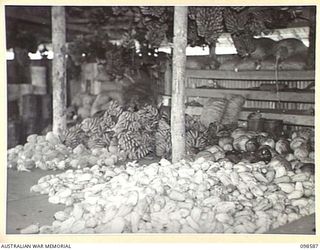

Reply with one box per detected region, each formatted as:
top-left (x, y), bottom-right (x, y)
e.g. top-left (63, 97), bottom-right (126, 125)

top-left (200, 98), bottom-right (227, 127)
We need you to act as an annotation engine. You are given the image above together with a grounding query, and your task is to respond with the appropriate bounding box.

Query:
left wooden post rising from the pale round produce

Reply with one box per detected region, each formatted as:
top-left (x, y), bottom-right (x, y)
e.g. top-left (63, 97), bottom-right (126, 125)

top-left (51, 6), bottom-right (67, 135)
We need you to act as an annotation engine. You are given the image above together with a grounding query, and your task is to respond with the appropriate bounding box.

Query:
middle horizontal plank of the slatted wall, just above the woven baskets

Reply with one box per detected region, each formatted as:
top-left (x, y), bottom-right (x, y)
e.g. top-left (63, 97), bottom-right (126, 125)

top-left (186, 88), bottom-right (315, 103)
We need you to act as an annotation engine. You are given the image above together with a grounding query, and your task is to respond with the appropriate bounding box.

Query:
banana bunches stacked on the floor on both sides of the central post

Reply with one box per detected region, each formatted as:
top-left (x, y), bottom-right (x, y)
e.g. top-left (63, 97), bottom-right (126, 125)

top-left (62, 101), bottom-right (207, 160)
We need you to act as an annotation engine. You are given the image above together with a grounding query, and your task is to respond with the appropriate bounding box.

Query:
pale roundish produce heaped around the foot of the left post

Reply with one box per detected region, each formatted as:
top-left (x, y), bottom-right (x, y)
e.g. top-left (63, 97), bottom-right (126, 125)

top-left (7, 132), bottom-right (122, 171)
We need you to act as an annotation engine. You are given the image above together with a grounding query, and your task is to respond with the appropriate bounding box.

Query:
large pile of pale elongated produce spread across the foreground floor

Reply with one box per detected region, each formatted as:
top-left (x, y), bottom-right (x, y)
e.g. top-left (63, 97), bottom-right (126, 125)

top-left (21, 153), bottom-right (315, 234)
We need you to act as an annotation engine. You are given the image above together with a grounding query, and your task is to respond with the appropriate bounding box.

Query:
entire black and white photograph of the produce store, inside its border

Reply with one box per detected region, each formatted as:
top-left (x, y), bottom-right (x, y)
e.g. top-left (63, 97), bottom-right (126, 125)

top-left (3, 5), bottom-right (319, 236)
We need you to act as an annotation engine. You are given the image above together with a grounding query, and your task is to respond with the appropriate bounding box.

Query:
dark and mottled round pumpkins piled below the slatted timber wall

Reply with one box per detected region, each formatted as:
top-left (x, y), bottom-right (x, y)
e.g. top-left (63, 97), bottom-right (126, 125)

top-left (195, 128), bottom-right (314, 171)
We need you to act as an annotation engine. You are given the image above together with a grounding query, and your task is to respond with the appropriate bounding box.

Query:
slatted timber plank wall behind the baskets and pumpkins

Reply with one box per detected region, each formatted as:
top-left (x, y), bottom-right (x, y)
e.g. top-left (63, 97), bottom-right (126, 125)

top-left (182, 69), bottom-right (315, 127)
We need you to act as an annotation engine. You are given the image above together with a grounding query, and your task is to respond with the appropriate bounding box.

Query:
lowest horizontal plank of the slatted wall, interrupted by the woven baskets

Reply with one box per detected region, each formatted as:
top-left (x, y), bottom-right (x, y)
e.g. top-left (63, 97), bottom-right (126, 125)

top-left (186, 106), bottom-right (314, 126)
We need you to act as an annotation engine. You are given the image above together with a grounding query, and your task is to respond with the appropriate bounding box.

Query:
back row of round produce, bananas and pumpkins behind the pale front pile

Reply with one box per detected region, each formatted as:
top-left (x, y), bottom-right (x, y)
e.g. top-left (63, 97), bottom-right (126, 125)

top-left (8, 97), bottom-right (314, 174)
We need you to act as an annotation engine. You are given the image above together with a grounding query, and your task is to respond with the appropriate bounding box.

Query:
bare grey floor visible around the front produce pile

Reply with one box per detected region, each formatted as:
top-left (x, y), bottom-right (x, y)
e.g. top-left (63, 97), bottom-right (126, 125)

top-left (6, 169), bottom-right (315, 235)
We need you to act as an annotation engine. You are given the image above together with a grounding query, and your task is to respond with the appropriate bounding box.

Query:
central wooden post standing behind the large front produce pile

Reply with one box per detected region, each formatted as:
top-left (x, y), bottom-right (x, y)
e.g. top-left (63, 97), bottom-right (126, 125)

top-left (171, 6), bottom-right (188, 162)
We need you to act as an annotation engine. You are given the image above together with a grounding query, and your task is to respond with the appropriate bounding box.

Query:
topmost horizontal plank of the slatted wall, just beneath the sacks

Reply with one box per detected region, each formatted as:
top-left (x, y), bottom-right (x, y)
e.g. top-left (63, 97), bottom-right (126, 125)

top-left (186, 69), bottom-right (315, 81)
